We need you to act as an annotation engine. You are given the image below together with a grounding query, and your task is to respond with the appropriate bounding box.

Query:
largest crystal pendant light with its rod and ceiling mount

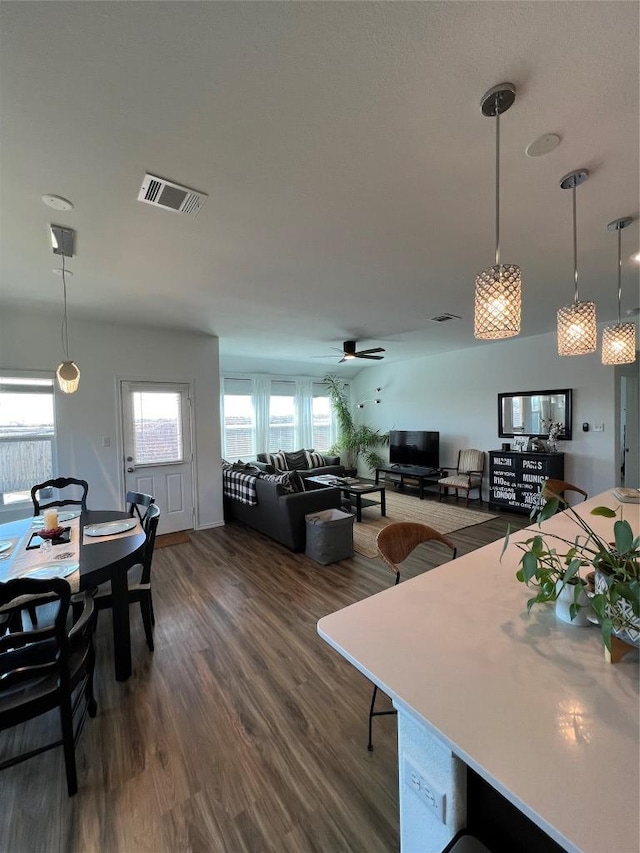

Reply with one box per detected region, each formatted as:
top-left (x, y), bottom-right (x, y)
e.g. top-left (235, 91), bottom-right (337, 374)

top-left (473, 83), bottom-right (522, 340)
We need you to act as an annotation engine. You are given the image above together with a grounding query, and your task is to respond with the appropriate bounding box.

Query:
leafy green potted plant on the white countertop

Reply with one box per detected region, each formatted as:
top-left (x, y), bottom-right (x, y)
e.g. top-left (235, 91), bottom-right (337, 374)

top-left (502, 486), bottom-right (640, 652)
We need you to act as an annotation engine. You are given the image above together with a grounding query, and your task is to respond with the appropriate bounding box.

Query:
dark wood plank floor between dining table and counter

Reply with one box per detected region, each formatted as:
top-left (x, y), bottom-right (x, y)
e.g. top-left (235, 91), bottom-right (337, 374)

top-left (0, 502), bottom-right (527, 853)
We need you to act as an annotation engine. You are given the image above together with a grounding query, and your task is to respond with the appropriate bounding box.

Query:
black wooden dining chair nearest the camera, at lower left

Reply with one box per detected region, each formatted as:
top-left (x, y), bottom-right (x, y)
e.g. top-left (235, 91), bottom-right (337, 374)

top-left (0, 578), bottom-right (97, 797)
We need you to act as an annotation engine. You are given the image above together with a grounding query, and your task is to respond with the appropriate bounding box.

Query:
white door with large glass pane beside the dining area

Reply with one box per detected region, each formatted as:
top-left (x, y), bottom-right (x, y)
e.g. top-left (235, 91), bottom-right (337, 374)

top-left (121, 382), bottom-right (193, 533)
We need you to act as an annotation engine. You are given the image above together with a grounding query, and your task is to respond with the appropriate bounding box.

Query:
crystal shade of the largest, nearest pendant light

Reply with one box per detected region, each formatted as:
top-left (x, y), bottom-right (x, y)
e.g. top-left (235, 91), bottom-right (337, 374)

top-left (473, 264), bottom-right (522, 341)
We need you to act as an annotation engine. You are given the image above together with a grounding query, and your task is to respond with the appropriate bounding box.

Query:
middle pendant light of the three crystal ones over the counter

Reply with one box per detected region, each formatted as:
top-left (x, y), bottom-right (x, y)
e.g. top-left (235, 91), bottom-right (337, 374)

top-left (558, 169), bottom-right (598, 355)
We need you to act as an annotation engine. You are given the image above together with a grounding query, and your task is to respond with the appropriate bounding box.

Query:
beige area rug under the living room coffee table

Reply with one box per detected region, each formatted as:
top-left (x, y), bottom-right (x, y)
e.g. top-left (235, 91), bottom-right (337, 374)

top-left (353, 489), bottom-right (498, 557)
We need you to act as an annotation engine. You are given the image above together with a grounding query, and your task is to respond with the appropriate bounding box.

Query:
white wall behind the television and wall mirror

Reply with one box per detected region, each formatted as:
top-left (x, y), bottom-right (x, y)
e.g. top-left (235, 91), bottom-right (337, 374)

top-left (351, 334), bottom-right (619, 494)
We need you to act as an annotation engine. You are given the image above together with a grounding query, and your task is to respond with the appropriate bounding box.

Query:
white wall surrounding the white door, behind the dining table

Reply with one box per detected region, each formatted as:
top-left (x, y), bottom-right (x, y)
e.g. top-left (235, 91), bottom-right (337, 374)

top-left (0, 308), bottom-right (223, 527)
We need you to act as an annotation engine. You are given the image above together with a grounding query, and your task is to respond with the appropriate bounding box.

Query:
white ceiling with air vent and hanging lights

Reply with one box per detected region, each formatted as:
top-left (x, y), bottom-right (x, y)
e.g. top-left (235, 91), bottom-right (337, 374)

top-left (0, 0), bottom-right (640, 375)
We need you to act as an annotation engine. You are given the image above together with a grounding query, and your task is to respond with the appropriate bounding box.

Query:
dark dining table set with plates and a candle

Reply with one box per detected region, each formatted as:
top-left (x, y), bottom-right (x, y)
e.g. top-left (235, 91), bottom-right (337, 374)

top-left (0, 510), bottom-right (146, 681)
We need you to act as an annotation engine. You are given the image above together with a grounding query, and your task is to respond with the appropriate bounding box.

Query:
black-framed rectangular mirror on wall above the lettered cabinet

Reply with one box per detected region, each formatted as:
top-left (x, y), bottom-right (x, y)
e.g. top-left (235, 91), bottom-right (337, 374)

top-left (498, 388), bottom-right (571, 441)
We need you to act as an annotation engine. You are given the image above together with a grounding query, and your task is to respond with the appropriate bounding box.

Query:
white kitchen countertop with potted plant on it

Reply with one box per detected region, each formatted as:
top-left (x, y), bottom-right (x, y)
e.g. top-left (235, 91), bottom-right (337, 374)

top-left (318, 492), bottom-right (640, 853)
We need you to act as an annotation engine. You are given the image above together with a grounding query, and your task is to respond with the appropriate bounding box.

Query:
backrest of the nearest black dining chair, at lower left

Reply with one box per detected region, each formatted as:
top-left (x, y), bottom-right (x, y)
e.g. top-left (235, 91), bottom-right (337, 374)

top-left (0, 578), bottom-right (71, 693)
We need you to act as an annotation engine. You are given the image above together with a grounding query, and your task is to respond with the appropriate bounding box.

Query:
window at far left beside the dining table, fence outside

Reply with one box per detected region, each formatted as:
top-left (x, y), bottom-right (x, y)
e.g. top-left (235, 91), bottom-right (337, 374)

top-left (0, 376), bottom-right (55, 505)
